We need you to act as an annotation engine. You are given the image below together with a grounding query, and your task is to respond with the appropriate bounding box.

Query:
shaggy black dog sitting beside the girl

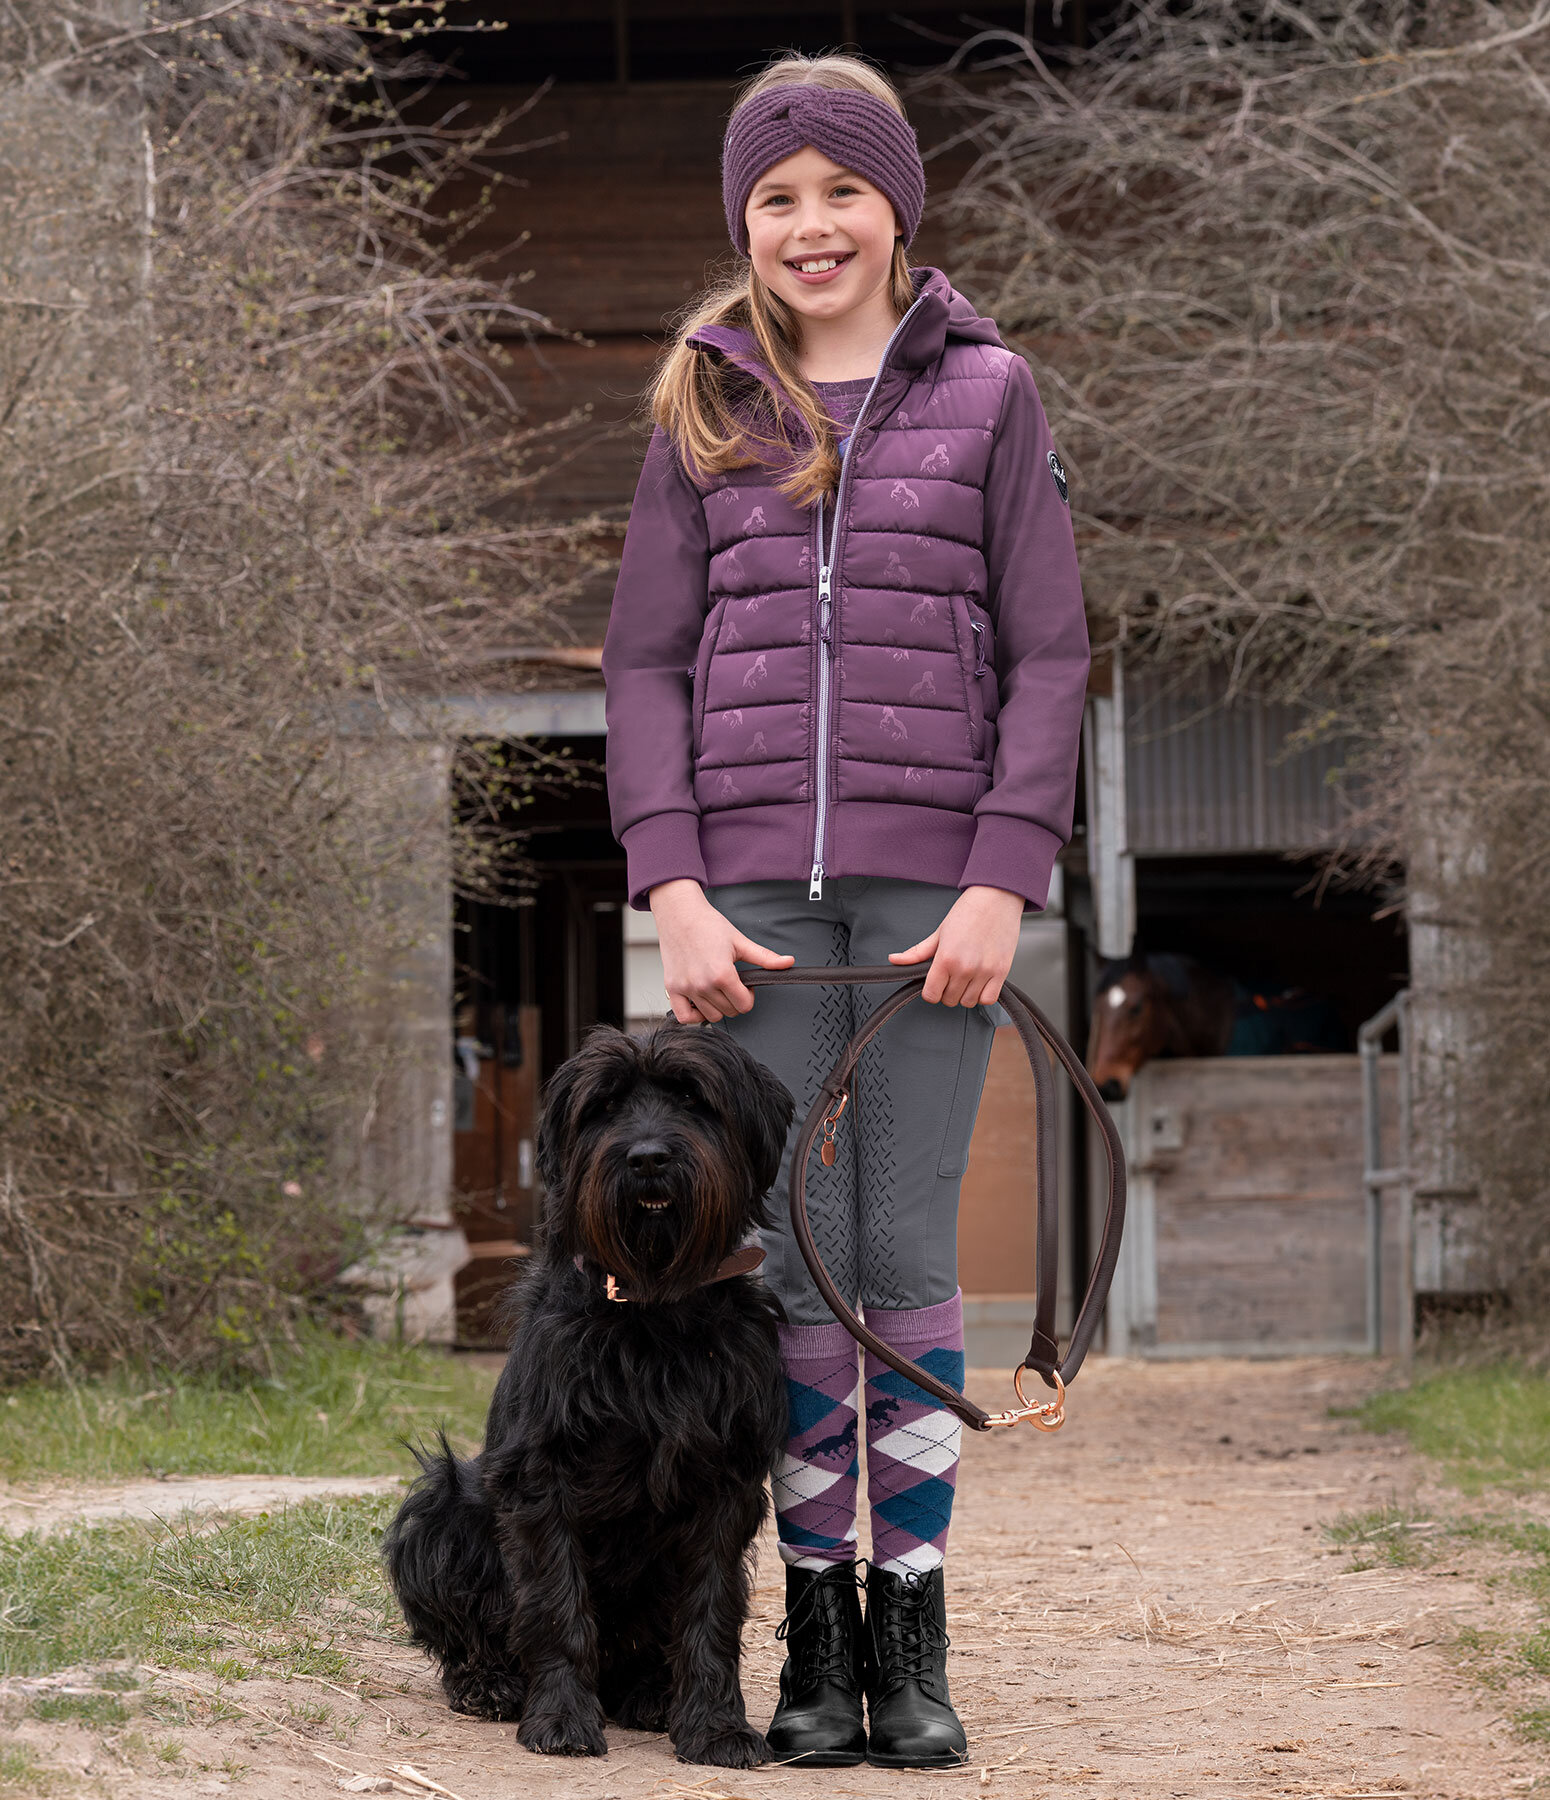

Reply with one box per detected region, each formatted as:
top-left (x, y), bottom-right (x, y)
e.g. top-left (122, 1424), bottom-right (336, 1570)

top-left (383, 1022), bottom-right (794, 1768)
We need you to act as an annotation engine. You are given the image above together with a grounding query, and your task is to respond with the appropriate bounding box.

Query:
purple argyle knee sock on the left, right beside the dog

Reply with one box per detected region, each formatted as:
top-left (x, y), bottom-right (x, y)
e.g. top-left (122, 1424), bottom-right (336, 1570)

top-left (770, 1323), bottom-right (859, 1570)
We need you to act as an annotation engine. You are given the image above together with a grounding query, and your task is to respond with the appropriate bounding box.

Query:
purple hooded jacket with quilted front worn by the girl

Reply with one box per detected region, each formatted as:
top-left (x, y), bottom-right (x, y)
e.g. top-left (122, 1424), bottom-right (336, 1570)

top-left (603, 268), bottom-right (1087, 909)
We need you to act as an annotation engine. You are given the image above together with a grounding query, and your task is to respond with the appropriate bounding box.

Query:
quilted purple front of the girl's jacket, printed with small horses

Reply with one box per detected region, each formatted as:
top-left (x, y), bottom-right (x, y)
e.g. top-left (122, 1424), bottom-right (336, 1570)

top-left (693, 381), bottom-right (1012, 828)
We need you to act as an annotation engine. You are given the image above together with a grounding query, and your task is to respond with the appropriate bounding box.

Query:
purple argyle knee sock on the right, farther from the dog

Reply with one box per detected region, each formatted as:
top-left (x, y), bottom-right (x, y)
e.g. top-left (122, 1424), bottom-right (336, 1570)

top-left (866, 1294), bottom-right (963, 1575)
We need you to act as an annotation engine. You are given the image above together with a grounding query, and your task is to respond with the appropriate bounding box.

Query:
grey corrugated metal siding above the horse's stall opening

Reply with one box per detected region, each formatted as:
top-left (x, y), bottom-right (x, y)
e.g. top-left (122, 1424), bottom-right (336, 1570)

top-left (1125, 668), bottom-right (1347, 857)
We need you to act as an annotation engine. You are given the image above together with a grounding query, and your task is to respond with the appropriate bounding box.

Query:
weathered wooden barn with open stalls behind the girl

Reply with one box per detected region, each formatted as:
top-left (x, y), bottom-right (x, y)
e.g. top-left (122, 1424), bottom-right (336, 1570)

top-left (351, 0), bottom-right (1476, 1363)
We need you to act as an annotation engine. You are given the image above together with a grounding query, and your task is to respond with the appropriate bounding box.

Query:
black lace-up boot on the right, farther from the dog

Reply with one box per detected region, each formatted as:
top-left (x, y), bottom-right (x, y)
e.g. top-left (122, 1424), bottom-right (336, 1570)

top-left (864, 1564), bottom-right (969, 1769)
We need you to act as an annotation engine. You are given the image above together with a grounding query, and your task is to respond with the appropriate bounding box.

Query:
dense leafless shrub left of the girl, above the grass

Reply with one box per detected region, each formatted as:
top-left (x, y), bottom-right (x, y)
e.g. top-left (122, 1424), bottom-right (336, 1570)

top-left (0, 0), bottom-right (612, 1375)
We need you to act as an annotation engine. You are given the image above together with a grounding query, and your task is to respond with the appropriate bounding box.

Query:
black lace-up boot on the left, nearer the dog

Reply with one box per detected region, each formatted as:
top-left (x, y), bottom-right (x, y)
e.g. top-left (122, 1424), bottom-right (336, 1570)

top-left (765, 1562), bottom-right (866, 1768)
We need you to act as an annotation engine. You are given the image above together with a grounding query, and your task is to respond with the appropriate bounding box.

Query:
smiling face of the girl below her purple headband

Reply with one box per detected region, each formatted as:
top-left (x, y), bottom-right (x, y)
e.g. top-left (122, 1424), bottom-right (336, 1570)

top-left (743, 144), bottom-right (902, 319)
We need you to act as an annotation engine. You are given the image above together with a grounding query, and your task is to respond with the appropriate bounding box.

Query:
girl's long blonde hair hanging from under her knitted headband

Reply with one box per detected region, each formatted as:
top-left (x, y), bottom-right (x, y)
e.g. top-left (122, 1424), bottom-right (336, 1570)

top-left (646, 50), bottom-right (915, 506)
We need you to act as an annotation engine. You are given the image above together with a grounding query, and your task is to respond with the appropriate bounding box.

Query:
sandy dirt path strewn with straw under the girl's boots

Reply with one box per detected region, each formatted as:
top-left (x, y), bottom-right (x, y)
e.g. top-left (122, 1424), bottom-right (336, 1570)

top-left (6, 1361), bottom-right (1550, 1800)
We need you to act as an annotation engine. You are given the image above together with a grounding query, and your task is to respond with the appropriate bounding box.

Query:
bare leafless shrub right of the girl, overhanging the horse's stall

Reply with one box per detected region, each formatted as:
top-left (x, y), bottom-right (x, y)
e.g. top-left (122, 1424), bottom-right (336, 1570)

top-left (947, 0), bottom-right (1550, 1296)
